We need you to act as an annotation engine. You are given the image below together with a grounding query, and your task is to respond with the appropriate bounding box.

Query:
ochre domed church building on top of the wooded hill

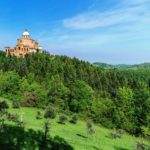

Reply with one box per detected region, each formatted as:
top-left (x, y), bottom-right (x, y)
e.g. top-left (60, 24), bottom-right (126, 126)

top-left (5, 30), bottom-right (43, 57)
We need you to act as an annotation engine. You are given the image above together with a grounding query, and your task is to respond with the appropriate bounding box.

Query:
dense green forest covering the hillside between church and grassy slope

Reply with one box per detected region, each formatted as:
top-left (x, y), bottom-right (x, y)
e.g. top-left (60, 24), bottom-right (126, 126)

top-left (0, 51), bottom-right (150, 136)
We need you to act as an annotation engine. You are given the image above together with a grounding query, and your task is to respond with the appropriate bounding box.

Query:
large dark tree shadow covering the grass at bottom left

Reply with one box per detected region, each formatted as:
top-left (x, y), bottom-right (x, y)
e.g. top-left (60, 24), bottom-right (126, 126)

top-left (0, 126), bottom-right (73, 150)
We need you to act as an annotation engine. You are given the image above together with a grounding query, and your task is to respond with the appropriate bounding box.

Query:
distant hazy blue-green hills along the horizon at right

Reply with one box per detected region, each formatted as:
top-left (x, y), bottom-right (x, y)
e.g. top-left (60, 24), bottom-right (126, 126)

top-left (93, 62), bottom-right (150, 69)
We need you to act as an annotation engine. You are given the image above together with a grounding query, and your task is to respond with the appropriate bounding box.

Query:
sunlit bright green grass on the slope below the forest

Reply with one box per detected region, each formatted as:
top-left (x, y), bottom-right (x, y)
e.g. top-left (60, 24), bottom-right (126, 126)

top-left (1, 98), bottom-right (150, 150)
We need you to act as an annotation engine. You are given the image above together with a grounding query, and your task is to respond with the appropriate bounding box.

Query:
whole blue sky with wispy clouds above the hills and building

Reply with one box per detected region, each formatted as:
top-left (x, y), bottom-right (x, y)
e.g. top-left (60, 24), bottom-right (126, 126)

top-left (0, 0), bottom-right (150, 64)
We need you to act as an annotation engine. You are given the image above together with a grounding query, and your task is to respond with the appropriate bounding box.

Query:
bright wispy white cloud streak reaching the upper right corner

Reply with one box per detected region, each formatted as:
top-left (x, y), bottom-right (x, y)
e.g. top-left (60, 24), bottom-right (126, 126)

top-left (63, 0), bottom-right (150, 29)
